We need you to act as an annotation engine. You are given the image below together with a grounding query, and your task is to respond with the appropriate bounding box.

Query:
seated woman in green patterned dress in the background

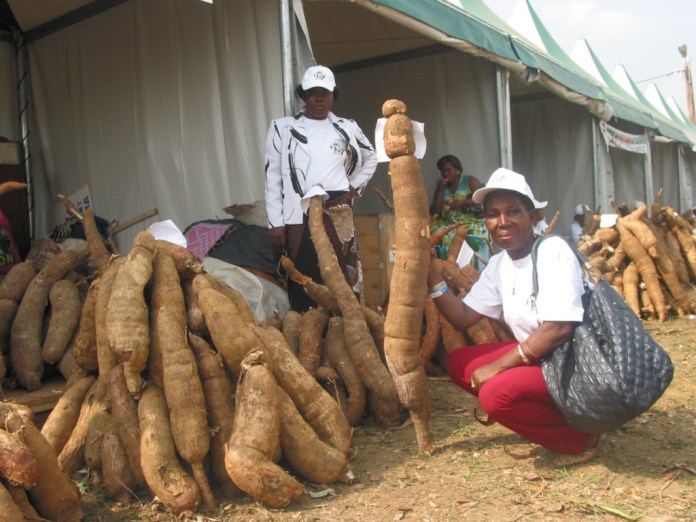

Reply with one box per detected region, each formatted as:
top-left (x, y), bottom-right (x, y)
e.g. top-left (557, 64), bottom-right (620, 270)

top-left (430, 154), bottom-right (490, 268)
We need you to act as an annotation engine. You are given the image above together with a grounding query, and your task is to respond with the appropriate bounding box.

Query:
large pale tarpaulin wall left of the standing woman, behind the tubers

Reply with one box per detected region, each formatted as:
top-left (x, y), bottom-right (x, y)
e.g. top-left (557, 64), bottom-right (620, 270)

top-left (29, 0), bottom-right (283, 249)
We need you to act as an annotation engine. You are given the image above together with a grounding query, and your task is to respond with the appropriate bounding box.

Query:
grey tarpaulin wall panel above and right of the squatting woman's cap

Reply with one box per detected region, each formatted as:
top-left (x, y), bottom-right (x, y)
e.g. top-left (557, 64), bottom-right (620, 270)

top-left (512, 98), bottom-right (594, 236)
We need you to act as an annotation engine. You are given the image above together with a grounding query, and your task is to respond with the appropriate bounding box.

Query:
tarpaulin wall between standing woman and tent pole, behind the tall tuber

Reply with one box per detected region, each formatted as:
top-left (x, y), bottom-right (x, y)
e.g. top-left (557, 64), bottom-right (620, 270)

top-left (334, 51), bottom-right (500, 214)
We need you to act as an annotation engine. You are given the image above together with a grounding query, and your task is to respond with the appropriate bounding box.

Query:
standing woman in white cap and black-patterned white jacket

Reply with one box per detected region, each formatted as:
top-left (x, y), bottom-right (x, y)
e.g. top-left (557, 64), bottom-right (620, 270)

top-left (265, 65), bottom-right (377, 312)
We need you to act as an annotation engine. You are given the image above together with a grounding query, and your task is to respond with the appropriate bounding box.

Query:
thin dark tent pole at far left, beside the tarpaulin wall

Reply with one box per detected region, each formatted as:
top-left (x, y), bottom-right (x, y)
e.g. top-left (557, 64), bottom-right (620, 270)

top-left (13, 28), bottom-right (34, 242)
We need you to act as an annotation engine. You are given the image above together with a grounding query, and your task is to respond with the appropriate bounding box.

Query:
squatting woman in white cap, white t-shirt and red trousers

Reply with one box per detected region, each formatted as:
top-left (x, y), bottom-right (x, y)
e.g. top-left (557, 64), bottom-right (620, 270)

top-left (428, 169), bottom-right (599, 465)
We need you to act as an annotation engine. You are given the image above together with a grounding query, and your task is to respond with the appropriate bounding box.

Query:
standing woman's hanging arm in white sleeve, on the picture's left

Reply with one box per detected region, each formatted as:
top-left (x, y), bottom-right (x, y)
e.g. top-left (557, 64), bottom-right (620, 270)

top-left (264, 121), bottom-right (287, 251)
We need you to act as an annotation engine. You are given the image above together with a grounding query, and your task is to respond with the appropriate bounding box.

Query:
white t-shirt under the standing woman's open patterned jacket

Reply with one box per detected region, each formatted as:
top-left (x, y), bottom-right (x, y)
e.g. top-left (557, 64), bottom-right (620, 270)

top-left (303, 117), bottom-right (349, 194)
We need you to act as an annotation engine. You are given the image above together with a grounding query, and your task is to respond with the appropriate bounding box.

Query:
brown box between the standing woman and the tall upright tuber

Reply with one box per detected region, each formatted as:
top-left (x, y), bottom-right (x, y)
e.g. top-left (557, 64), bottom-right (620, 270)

top-left (355, 214), bottom-right (394, 309)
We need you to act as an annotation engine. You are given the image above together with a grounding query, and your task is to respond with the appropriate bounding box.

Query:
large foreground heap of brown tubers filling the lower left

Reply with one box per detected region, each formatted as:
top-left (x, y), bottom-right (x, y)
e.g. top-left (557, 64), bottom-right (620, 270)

top-left (0, 183), bottom-right (410, 520)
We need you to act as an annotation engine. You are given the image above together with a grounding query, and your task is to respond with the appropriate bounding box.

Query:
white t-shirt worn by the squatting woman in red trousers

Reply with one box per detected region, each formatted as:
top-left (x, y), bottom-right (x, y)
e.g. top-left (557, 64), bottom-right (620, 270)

top-left (464, 237), bottom-right (584, 342)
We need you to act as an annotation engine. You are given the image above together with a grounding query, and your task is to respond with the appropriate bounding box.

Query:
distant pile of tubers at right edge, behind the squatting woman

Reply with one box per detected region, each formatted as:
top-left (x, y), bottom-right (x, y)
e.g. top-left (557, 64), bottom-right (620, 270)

top-left (577, 189), bottom-right (696, 322)
